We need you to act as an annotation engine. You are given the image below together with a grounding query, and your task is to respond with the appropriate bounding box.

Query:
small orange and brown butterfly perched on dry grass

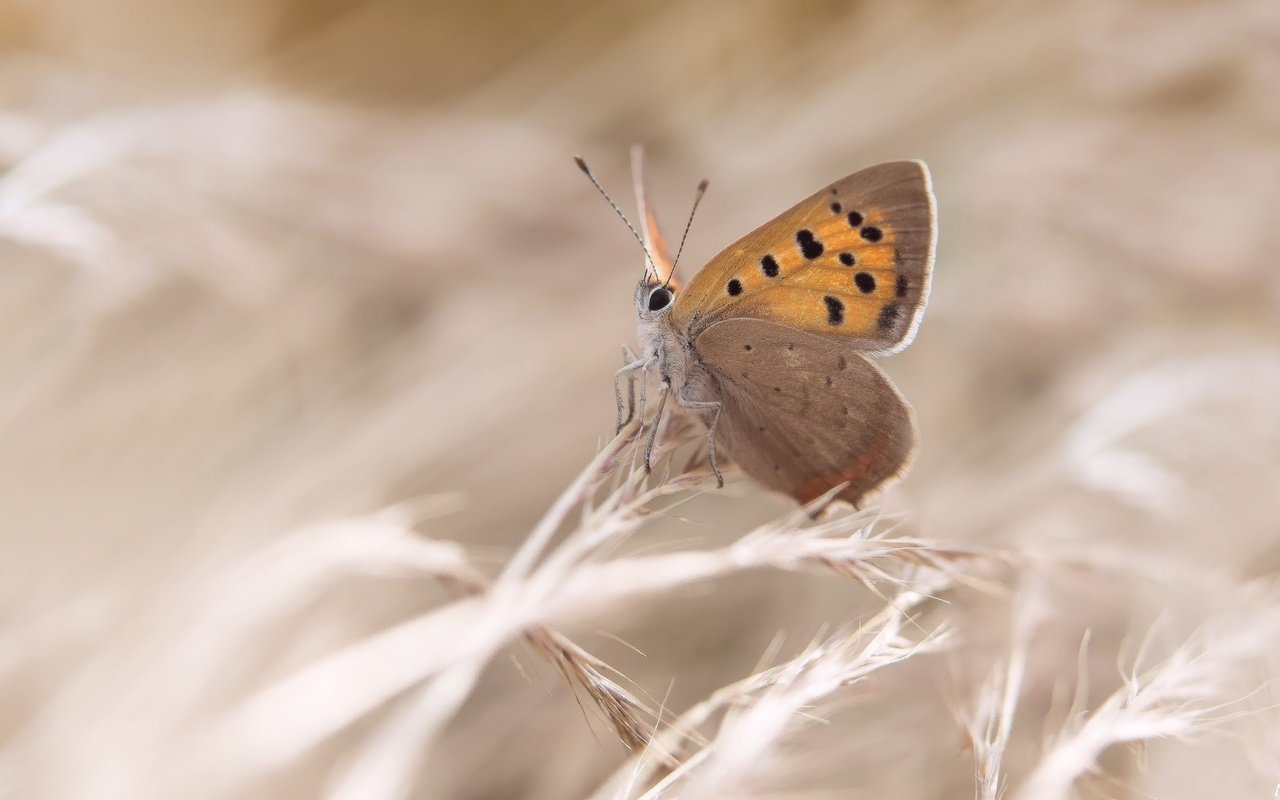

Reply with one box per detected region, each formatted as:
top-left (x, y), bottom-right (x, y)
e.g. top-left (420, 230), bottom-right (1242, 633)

top-left (577, 150), bottom-right (937, 507)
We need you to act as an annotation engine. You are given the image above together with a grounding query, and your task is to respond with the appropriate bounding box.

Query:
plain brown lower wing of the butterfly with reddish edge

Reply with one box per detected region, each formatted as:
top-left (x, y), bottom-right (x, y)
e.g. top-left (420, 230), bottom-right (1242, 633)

top-left (694, 319), bottom-right (915, 506)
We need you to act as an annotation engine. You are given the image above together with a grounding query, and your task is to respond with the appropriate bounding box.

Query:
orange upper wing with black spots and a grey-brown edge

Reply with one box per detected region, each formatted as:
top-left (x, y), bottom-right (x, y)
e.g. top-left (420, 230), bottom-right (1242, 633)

top-left (672, 161), bottom-right (937, 353)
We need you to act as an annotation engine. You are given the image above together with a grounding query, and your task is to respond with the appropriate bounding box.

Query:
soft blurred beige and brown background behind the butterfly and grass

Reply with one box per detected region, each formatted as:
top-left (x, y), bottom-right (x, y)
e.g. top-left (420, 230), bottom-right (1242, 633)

top-left (0, 0), bottom-right (1280, 797)
